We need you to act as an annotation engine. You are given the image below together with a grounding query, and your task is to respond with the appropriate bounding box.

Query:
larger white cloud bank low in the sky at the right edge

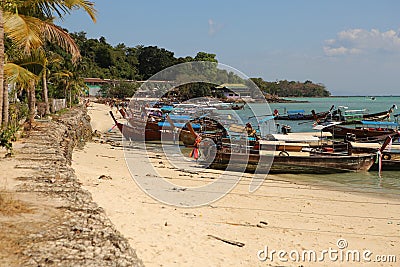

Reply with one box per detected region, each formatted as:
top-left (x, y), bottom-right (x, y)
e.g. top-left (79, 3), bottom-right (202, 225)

top-left (323, 29), bottom-right (400, 56)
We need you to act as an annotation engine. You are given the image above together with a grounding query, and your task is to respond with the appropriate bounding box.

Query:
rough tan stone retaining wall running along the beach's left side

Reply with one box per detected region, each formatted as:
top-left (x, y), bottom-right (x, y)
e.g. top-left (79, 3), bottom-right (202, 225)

top-left (10, 108), bottom-right (143, 266)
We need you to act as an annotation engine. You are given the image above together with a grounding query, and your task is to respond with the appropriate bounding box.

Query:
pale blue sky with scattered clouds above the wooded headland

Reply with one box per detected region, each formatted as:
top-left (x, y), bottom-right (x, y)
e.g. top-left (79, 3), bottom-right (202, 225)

top-left (59, 0), bottom-right (400, 95)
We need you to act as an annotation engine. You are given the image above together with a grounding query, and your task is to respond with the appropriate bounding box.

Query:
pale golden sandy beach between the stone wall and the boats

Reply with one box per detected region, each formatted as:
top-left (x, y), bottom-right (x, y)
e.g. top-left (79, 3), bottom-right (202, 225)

top-left (72, 103), bottom-right (400, 266)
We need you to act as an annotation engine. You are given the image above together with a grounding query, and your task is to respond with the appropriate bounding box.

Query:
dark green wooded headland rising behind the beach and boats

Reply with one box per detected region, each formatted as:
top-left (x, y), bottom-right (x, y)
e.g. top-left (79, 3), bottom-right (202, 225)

top-left (71, 32), bottom-right (330, 100)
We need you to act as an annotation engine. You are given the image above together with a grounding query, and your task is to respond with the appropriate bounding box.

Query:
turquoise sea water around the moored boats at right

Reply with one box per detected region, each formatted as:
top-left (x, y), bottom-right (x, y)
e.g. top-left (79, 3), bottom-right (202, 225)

top-left (236, 96), bottom-right (400, 199)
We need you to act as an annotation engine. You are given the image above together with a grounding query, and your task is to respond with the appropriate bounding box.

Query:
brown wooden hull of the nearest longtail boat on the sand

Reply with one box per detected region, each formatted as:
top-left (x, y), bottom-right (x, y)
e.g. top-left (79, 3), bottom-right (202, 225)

top-left (206, 152), bottom-right (375, 174)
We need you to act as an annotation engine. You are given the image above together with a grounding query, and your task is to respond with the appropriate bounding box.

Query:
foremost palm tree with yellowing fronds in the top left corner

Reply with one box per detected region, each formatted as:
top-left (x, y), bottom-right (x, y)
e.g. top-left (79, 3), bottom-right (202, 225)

top-left (0, 0), bottom-right (96, 125)
